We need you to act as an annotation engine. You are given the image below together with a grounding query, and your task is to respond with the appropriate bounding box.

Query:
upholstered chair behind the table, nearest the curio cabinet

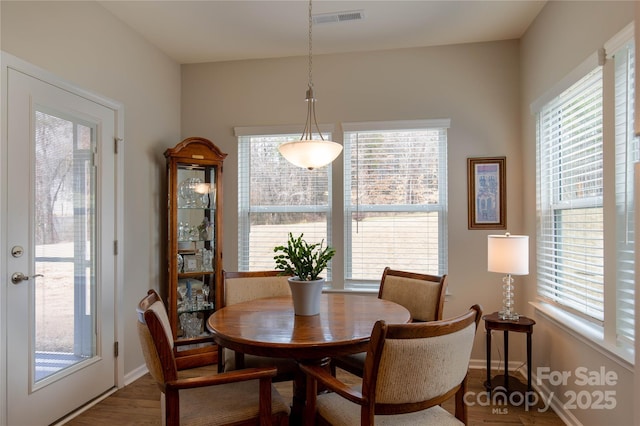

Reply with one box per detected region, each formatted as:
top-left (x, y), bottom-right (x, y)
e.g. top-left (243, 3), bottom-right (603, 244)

top-left (216, 270), bottom-right (298, 382)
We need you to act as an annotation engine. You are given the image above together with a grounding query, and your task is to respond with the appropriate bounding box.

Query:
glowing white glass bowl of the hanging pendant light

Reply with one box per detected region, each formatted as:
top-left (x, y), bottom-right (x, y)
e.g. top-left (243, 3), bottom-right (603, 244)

top-left (278, 139), bottom-right (342, 169)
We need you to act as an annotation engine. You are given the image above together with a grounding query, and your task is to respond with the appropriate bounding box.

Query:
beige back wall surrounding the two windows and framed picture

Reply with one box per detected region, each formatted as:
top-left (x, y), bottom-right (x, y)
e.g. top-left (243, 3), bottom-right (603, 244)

top-left (182, 41), bottom-right (522, 360)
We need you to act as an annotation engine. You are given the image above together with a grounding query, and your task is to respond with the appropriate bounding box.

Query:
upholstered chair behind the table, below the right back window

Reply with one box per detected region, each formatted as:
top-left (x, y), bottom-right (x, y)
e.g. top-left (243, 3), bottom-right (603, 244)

top-left (331, 266), bottom-right (447, 377)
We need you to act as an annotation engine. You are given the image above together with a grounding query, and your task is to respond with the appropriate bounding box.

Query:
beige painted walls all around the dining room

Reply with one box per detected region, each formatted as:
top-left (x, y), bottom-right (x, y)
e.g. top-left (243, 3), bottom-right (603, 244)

top-left (0, 1), bottom-right (633, 424)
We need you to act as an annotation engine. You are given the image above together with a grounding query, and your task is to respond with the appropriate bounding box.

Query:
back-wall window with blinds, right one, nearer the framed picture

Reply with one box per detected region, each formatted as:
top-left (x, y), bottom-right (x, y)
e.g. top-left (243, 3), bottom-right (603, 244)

top-left (343, 120), bottom-right (449, 289)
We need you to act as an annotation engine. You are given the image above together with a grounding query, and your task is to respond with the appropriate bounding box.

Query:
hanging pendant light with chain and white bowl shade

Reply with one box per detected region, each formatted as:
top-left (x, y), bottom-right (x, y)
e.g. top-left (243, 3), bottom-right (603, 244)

top-left (278, 0), bottom-right (342, 170)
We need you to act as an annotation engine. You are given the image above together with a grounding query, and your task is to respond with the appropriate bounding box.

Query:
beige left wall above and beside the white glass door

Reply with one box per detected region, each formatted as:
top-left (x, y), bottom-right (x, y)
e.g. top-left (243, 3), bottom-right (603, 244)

top-left (0, 1), bottom-right (180, 374)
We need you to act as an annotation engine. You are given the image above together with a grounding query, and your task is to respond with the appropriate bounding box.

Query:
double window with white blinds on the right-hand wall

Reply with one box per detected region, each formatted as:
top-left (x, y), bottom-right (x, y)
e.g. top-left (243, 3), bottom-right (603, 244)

top-left (537, 27), bottom-right (640, 360)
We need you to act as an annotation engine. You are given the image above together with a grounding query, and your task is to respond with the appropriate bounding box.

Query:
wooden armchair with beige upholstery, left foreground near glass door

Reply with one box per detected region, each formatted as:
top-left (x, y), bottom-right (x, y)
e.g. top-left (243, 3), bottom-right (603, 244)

top-left (137, 290), bottom-right (289, 426)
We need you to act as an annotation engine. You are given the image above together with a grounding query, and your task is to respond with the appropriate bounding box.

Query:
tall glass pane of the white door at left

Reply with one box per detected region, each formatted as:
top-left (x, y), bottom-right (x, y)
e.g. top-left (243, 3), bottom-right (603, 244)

top-left (31, 109), bottom-right (96, 381)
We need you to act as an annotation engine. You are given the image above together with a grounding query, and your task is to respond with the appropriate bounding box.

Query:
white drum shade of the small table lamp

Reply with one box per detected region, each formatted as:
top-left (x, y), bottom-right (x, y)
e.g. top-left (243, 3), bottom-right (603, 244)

top-left (487, 234), bottom-right (529, 275)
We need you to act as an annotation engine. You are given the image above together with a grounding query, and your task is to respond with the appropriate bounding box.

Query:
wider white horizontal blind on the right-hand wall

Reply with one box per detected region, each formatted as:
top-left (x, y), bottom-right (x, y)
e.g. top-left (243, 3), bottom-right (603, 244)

top-left (537, 66), bottom-right (604, 321)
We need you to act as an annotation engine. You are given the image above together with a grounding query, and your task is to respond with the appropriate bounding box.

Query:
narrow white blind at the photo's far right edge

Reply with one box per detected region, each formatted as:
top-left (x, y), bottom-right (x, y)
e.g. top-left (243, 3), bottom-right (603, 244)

top-left (613, 42), bottom-right (640, 346)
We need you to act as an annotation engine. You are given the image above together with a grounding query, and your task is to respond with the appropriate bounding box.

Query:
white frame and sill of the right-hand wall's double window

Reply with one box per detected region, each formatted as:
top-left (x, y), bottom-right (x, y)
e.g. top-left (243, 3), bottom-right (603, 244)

top-left (531, 23), bottom-right (640, 362)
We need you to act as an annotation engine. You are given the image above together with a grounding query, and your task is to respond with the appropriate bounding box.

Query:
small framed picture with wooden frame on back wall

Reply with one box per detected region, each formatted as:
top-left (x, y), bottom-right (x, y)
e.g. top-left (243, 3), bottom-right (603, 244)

top-left (467, 157), bottom-right (507, 229)
